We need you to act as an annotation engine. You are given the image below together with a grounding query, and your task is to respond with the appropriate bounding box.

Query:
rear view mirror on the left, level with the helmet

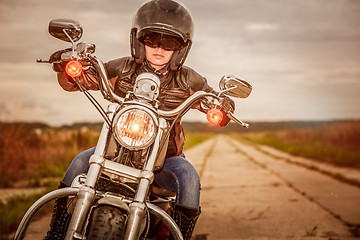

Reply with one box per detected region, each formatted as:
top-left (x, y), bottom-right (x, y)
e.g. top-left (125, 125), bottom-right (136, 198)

top-left (49, 19), bottom-right (83, 43)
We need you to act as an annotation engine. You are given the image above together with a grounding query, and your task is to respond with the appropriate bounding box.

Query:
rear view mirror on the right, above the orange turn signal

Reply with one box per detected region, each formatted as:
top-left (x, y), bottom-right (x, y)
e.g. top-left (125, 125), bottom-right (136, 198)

top-left (219, 74), bottom-right (252, 98)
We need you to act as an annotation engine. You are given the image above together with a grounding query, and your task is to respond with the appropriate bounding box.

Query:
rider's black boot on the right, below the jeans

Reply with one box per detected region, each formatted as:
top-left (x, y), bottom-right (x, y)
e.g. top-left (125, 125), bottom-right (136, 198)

top-left (170, 205), bottom-right (201, 240)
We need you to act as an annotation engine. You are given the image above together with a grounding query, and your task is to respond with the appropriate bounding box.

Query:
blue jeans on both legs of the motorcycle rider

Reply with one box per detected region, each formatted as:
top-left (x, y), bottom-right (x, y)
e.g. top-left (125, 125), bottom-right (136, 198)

top-left (63, 148), bottom-right (200, 209)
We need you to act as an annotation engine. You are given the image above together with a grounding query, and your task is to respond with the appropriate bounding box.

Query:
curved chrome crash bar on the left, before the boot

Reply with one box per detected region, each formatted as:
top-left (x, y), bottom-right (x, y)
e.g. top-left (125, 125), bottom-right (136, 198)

top-left (14, 187), bottom-right (79, 240)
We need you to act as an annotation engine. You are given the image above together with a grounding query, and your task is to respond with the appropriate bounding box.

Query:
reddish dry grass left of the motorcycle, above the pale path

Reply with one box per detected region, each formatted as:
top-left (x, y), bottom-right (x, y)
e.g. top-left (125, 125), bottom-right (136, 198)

top-left (0, 123), bottom-right (98, 187)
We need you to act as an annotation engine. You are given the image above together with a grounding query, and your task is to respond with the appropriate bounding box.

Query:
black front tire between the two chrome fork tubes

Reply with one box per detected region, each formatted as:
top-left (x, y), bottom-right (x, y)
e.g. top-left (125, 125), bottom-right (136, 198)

top-left (86, 205), bottom-right (127, 240)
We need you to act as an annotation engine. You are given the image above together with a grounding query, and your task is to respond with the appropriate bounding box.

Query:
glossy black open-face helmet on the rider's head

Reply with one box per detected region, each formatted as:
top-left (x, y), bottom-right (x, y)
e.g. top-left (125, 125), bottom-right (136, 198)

top-left (130, 0), bottom-right (194, 70)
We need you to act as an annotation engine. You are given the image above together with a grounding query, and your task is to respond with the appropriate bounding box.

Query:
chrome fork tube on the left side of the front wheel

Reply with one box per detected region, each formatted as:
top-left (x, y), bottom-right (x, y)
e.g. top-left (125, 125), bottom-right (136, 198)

top-left (65, 106), bottom-right (114, 240)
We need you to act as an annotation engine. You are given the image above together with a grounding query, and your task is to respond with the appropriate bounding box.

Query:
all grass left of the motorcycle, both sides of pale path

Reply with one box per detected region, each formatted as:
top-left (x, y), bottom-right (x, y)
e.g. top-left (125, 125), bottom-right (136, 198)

top-left (0, 123), bottom-right (98, 239)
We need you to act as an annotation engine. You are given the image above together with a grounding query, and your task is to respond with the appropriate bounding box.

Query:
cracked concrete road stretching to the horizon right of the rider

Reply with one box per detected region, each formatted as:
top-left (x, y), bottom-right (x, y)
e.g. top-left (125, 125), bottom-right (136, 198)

top-left (185, 136), bottom-right (360, 239)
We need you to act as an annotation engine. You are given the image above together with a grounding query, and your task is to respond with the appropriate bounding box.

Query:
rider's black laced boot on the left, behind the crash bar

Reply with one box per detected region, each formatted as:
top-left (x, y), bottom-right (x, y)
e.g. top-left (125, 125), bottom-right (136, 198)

top-left (44, 182), bottom-right (71, 240)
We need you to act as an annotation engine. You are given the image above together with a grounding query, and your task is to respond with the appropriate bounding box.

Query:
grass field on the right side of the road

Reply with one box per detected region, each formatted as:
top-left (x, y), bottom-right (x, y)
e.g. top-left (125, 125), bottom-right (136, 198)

top-left (235, 121), bottom-right (360, 168)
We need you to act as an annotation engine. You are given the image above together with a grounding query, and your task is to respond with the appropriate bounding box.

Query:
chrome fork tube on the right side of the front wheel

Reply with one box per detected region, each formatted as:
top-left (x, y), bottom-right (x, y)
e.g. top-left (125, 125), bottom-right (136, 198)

top-left (125, 119), bottom-right (165, 240)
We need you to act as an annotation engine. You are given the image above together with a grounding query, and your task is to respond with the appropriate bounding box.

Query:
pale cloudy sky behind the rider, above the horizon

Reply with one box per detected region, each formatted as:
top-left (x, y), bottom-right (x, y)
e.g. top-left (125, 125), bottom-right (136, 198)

top-left (0, 0), bottom-right (360, 125)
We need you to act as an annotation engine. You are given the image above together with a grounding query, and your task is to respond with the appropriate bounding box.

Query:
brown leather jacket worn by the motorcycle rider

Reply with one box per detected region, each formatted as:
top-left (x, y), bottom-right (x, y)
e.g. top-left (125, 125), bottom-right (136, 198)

top-left (58, 57), bottom-right (215, 157)
